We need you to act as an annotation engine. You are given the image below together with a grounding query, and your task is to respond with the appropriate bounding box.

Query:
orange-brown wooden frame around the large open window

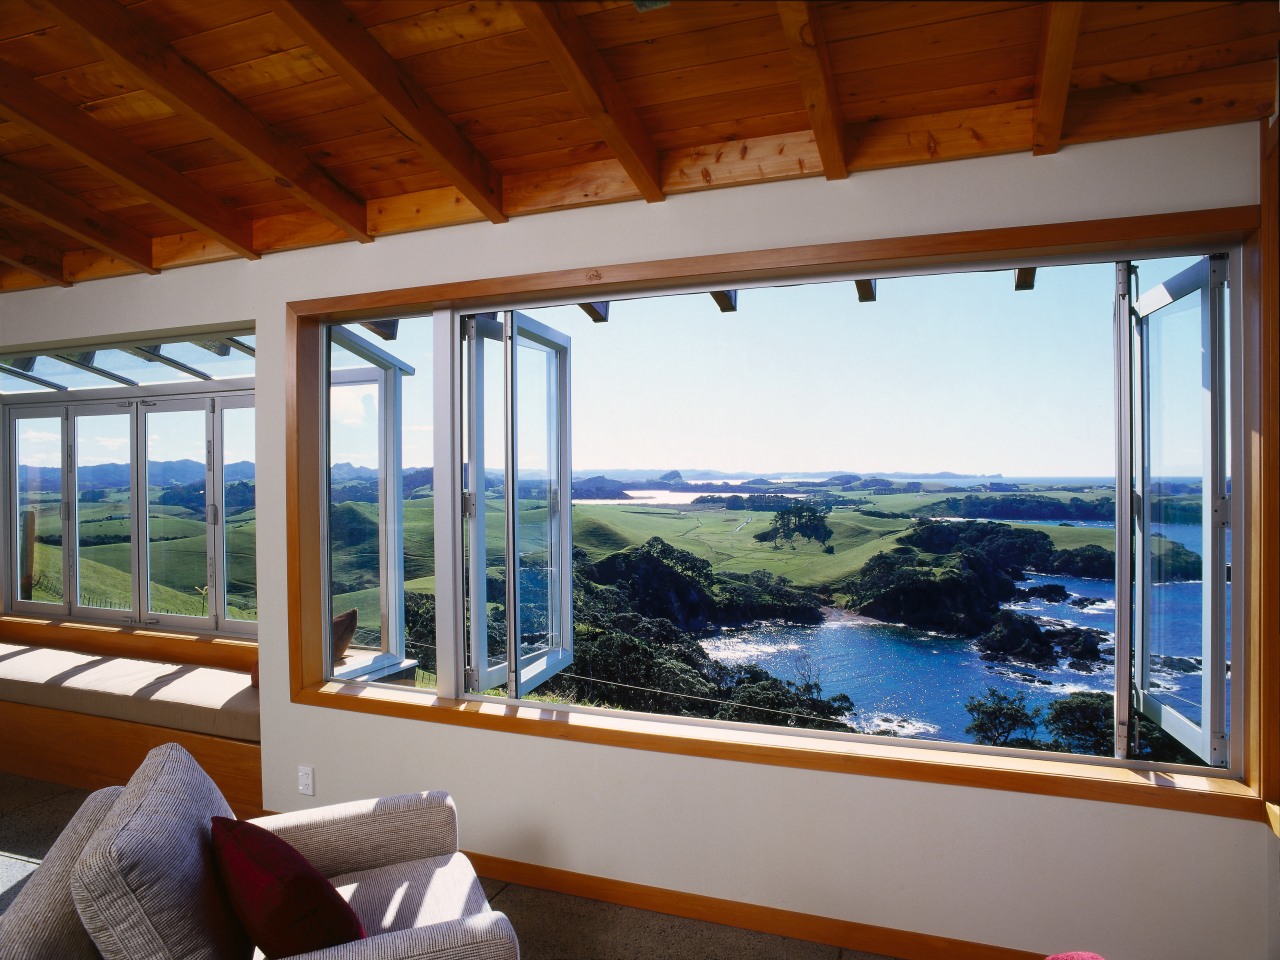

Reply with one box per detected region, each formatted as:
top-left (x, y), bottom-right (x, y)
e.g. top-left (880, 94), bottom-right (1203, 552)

top-left (285, 204), bottom-right (1280, 827)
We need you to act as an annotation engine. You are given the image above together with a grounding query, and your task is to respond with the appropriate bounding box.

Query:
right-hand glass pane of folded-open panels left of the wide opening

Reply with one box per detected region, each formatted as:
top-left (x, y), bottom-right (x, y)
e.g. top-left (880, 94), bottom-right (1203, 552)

top-left (516, 342), bottom-right (559, 670)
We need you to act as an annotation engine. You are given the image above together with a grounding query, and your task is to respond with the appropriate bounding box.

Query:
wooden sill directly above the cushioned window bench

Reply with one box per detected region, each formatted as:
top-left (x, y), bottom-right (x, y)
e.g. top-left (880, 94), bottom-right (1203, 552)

top-left (0, 614), bottom-right (257, 672)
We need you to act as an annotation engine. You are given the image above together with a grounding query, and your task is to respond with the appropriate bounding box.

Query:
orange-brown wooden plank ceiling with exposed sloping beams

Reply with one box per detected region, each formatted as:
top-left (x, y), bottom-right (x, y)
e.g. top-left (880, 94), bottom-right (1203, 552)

top-left (0, 0), bottom-right (1280, 291)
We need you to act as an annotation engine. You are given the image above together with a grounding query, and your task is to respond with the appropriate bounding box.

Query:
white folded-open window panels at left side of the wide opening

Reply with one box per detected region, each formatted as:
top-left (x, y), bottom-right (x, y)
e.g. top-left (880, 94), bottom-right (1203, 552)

top-left (463, 311), bottom-right (573, 699)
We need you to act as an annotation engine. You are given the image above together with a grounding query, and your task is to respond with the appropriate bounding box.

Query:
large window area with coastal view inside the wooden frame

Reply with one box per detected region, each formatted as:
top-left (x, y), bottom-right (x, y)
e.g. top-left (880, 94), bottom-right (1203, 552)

top-left (314, 257), bottom-right (1239, 767)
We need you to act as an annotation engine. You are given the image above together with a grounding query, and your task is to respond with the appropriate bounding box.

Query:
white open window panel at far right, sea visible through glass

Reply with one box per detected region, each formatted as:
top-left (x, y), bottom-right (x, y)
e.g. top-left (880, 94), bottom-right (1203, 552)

top-left (1116, 256), bottom-right (1231, 767)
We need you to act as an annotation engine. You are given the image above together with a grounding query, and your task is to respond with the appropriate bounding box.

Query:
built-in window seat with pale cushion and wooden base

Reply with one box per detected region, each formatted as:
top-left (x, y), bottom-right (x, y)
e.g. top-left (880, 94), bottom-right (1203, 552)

top-left (0, 640), bottom-right (264, 817)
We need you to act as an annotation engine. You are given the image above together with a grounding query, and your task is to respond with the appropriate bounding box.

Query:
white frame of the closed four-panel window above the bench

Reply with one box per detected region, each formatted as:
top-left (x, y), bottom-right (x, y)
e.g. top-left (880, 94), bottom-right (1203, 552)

top-left (0, 378), bottom-right (257, 641)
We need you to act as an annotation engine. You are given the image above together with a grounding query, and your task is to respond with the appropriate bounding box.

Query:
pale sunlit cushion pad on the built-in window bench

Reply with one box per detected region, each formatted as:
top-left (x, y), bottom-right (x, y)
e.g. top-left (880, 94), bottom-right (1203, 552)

top-left (0, 643), bottom-right (261, 742)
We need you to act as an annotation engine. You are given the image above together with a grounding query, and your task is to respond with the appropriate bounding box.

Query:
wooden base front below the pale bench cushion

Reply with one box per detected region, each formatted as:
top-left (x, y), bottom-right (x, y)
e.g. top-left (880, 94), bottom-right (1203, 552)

top-left (0, 700), bottom-right (265, 818)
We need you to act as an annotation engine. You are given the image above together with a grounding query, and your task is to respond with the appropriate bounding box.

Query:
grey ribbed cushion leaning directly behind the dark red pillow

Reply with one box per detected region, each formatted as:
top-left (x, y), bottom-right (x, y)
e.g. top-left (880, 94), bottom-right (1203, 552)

top-left (72, 744), bottom-right (253, 960)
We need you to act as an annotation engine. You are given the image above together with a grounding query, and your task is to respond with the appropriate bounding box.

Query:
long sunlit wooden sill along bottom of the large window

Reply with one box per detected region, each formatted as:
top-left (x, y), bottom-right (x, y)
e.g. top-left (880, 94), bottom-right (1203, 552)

top-left (293, 681), bottom-right (1268, 823)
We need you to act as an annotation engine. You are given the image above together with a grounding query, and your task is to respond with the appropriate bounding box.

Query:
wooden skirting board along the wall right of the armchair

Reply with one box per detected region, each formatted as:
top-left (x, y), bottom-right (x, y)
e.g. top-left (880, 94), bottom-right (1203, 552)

top-left (467, 851), bottom-right (1044, 960)
